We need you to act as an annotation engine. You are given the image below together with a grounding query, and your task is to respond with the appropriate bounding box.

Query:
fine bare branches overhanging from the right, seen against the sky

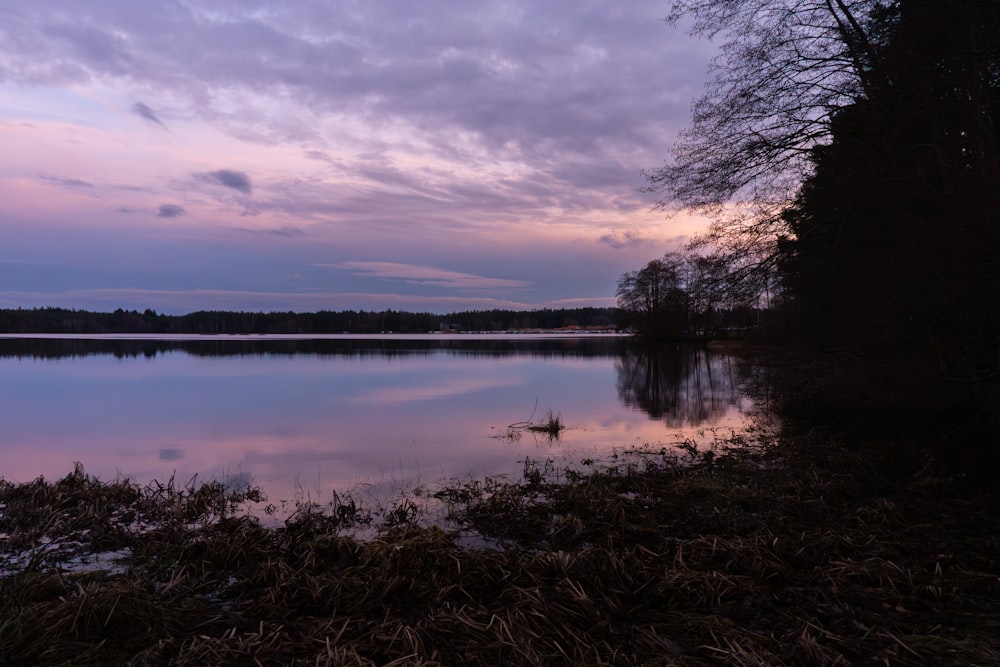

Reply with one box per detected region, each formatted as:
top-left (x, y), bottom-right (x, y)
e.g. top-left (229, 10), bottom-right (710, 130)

top-left (646, 0), bottom-right (895, 310)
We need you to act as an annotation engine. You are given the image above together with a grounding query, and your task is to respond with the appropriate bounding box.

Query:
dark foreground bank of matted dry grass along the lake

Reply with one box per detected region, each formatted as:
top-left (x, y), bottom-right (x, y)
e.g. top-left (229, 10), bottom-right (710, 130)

top-left (0, 432), bottom-right (1000, 665)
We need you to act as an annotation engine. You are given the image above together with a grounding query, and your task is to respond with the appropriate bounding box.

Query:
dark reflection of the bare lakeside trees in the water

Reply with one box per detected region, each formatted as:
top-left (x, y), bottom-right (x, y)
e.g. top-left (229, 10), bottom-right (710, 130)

top-left (615, 344), bottom-right (743, 428)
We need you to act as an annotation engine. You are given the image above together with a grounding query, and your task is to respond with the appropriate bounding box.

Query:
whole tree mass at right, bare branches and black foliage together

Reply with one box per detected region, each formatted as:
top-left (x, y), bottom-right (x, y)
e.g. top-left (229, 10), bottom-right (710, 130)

top-left (647, 0), bottom-right (1000, 472)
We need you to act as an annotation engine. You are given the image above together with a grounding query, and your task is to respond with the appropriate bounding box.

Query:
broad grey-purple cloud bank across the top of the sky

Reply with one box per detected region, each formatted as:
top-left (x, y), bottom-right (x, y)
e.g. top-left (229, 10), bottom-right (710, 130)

top-left (0, 0), bottom-right (711, 173)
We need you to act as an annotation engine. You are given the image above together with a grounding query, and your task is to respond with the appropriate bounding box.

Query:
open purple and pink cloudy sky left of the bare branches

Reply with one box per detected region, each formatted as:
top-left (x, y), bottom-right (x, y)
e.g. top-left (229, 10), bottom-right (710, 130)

top-left (0, 0), bottom-right (713, 313)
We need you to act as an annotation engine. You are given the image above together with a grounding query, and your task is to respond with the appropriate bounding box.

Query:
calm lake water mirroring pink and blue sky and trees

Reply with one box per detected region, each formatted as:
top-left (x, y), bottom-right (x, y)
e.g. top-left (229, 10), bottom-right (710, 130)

top-left (0, 335), bottom-right (748, 502)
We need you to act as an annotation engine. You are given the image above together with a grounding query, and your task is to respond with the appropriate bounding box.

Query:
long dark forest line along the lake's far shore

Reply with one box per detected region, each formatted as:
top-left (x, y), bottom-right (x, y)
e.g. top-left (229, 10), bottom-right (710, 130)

top-left (0, 307), bottom-right (621, 334)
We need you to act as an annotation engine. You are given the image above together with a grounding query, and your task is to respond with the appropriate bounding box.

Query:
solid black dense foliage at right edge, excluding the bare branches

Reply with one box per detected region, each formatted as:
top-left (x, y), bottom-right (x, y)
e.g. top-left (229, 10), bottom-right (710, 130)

top-left (783, 0), bottom-right (1000, 474)
